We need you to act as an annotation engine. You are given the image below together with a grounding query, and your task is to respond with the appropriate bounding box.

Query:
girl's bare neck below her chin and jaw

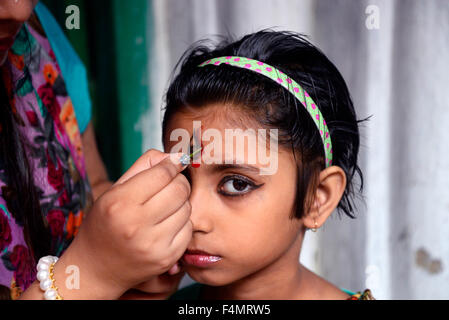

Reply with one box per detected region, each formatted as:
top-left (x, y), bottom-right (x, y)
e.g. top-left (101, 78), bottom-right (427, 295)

top-left (202, 232), bottom-right (307, 300)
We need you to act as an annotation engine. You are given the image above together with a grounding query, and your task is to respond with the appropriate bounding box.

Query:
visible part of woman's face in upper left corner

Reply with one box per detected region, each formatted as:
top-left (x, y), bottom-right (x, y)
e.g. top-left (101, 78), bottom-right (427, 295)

top-left (0, 0), bottom-right (38, 66)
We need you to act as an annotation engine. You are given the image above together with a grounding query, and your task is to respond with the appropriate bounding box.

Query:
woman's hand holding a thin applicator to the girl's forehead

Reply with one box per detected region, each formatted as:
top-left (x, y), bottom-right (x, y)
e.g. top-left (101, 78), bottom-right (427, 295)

top-left (46, 150), bottom-right (192, 299)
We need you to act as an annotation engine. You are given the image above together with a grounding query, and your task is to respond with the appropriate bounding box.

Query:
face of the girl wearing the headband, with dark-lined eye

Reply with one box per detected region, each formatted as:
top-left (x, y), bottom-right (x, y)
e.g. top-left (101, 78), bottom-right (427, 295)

top-left (164, 105), bottom-right (303, 286)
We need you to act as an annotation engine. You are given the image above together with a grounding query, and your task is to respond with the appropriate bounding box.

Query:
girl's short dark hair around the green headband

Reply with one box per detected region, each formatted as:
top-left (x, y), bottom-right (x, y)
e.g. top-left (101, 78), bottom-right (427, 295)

top-left (162, 29), bottom-right (366, 218)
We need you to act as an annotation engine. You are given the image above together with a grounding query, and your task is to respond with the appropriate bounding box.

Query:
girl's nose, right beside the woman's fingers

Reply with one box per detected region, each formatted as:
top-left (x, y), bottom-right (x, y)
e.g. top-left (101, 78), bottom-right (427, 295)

top-left (189, 185), bottom-right (214, 233)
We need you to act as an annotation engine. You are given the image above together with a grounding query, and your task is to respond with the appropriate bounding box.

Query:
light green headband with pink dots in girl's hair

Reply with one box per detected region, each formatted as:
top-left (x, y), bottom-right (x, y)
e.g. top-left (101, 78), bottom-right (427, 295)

top-left (199, 56), bottom-right (332, 168)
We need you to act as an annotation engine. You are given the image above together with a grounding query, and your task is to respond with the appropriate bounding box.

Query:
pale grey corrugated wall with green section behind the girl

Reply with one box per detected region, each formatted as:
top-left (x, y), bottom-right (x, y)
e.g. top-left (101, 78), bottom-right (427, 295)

top-left (44, 0), bottom-right (449, 299)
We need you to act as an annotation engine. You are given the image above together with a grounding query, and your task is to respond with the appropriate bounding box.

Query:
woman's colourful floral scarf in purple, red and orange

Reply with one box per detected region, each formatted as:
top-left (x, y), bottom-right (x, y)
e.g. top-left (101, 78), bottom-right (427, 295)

top-left (0, 24), bottom-right (93, 299)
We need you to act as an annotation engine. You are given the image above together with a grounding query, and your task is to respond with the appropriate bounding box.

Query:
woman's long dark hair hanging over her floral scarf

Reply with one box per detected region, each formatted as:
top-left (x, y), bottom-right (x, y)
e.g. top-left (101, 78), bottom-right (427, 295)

top-left (0, 22), bottom-right (51, 263)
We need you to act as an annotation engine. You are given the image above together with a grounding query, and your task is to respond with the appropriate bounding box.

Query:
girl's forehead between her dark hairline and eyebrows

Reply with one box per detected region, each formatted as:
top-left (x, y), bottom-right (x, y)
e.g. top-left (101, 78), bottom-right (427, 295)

top-left (164, 105), bottom-right (280, 175)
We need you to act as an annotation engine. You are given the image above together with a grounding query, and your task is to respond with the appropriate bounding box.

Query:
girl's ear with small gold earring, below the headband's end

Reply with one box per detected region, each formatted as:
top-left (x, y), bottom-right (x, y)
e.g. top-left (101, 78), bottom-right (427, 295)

top-left (303, 166), bottom-right (346, 229)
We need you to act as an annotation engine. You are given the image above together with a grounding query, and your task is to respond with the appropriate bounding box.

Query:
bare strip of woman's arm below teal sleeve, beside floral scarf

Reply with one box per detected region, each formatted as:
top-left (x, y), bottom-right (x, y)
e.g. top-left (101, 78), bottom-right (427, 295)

top-left (82, 122), bottom-right (112, 200)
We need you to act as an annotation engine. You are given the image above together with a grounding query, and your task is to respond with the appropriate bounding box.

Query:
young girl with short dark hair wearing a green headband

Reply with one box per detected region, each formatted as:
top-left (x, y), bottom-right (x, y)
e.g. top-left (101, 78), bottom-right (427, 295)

top-left (163, 30), bottom-right (372, 299)
